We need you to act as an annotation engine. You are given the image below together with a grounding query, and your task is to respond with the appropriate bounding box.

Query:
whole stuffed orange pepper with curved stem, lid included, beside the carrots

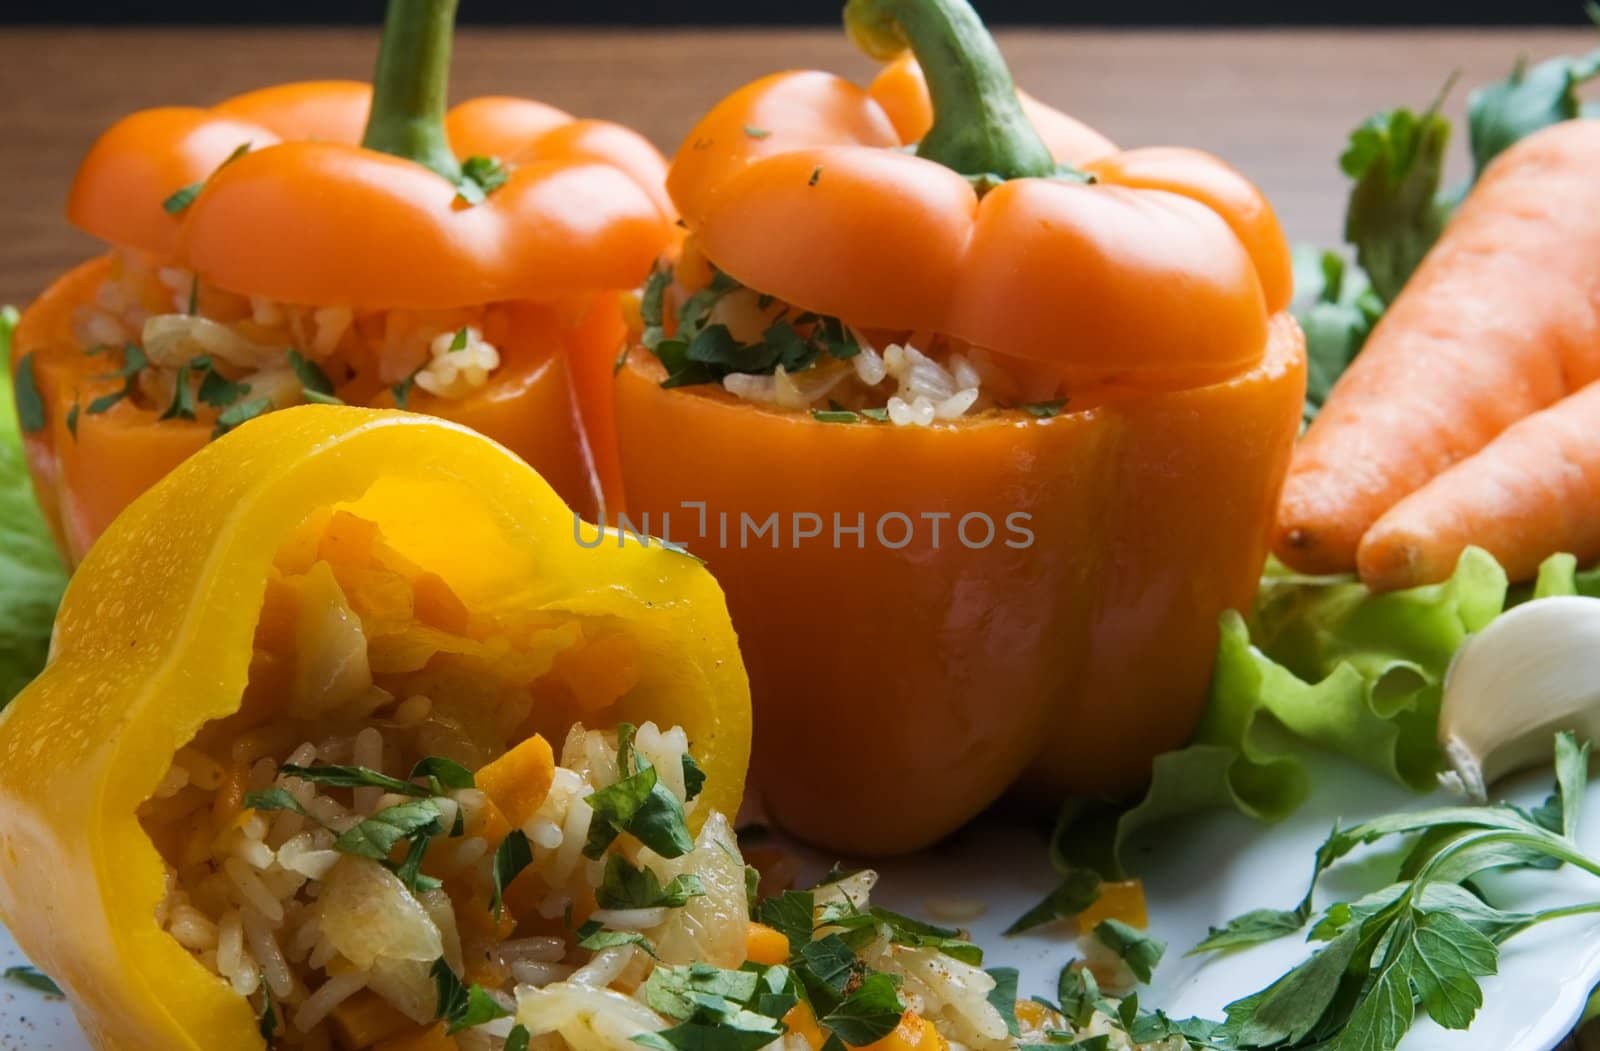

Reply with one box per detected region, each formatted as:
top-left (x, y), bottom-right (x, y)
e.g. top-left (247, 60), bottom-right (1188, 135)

top-left (616, 0), bottom-right (1304, 854)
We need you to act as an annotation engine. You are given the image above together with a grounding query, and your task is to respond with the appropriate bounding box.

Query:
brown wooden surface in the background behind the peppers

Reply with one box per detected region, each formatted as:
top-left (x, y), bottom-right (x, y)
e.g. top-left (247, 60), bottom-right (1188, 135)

top-left (0, 29), bottom-right (1594, 302)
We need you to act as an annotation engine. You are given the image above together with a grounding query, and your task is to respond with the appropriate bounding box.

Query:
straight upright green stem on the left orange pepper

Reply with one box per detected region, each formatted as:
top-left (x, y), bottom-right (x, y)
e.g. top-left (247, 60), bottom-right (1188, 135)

top-left (362, 0), bottom-right (461, 181)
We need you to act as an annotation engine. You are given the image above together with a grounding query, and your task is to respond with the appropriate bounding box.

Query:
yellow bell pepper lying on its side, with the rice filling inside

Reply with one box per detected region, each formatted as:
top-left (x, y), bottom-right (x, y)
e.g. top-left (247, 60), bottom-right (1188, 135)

top-left (0, 406), bottom-right (750, 1051)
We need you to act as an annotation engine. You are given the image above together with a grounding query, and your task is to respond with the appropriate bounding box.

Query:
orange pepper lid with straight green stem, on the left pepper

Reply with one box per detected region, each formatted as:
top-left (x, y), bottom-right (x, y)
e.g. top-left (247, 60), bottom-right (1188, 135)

top-left (67, 0), bottom-right (675, 309)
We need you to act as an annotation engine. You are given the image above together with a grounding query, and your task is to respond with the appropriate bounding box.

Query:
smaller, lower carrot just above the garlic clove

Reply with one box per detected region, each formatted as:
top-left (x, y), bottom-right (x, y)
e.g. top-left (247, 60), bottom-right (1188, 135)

top-left (1355, 382), bottom-right (1600, 590)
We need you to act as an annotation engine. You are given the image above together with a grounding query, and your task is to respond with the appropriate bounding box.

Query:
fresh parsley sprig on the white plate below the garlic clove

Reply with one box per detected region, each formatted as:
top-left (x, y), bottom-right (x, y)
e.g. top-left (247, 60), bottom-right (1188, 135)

top-left (1130, 734), bottom-right (1600, 1051)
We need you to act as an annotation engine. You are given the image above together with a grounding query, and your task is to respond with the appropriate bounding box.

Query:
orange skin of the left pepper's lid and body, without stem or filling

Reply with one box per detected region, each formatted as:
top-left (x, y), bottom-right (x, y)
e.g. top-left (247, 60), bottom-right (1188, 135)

top-left (26, 82), bottom-right (677, 563)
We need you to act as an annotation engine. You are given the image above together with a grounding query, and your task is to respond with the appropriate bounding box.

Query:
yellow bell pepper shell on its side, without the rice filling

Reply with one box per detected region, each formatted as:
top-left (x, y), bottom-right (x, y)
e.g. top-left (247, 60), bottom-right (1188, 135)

top-left (0, 406), bottom-right (750, 1051)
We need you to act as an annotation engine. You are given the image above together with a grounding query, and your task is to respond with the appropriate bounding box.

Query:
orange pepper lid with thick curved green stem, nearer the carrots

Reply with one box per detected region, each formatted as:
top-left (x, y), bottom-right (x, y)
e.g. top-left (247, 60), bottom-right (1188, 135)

top-left (667, 0), bottom-right (1293, 387)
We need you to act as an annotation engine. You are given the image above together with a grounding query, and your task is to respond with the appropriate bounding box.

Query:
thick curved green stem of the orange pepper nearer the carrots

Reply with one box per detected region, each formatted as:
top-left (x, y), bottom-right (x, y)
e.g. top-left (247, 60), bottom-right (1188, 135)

top-left (845, 0), bottom-right (1056, 179)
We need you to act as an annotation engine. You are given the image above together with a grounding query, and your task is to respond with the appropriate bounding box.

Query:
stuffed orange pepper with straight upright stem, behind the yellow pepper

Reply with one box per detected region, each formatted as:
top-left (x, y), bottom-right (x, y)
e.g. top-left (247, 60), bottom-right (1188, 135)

top-left (11, 0), bottom-right (674, 561)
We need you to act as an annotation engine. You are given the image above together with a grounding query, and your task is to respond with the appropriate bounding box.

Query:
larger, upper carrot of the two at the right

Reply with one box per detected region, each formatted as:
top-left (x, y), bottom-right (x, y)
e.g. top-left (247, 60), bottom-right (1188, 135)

top-left (1274, 120), bottom-right (1600, 581)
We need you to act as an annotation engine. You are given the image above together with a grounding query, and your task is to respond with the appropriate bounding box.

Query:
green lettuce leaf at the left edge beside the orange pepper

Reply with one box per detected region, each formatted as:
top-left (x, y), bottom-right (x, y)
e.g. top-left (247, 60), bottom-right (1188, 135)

top-left (0, 307), bottom-right (67, 707)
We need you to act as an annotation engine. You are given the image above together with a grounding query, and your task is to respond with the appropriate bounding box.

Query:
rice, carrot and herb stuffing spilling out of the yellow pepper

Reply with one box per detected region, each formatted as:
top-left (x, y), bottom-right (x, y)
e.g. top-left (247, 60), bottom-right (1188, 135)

top-left (139, 510), bottom-right (1176, 1051)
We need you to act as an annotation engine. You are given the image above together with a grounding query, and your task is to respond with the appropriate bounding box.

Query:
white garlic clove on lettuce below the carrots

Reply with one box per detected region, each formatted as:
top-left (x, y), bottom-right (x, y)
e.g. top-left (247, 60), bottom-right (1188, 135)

top-left (1438, 595), bottom-right (1600, 801)
